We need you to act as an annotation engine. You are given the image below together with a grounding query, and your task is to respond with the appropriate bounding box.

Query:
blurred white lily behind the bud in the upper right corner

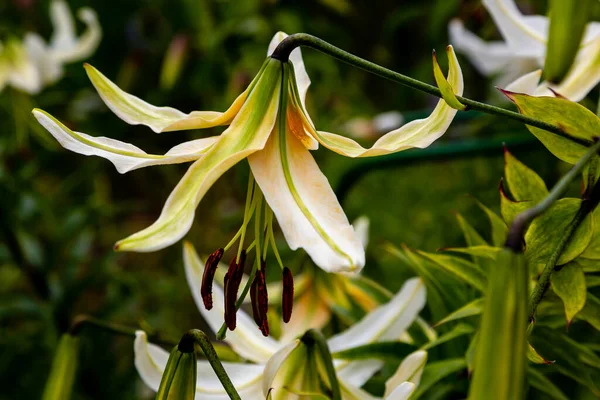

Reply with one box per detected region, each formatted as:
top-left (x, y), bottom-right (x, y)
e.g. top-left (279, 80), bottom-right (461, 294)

top-left (449, 0), bottom-right (600, 101)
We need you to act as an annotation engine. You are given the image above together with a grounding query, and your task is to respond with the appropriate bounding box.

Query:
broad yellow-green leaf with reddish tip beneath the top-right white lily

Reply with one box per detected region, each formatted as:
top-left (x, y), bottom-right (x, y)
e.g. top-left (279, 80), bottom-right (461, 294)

top-left (503, 91), bottom-right (600, 164)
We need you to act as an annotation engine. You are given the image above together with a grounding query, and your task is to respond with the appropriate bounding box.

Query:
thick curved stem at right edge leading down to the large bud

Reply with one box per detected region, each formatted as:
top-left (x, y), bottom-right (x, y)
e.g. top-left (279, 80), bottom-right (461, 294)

top-left (505, 141), bottom-right (600, 252)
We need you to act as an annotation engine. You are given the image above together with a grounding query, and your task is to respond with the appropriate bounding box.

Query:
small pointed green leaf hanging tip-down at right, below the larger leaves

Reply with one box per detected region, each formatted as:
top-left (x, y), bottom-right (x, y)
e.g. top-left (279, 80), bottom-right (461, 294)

top-left (550, 263), bottom-right (587, 325)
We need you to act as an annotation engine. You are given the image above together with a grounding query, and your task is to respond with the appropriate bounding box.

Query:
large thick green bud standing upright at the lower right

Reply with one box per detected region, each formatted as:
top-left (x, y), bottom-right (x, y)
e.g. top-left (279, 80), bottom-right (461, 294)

top-left (469, 248), bottom-right (528, 400)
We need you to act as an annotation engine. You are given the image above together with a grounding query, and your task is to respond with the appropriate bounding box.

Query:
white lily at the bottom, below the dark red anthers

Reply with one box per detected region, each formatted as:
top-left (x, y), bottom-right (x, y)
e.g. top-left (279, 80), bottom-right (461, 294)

top-left (134, 242), bottom-right (426, 400)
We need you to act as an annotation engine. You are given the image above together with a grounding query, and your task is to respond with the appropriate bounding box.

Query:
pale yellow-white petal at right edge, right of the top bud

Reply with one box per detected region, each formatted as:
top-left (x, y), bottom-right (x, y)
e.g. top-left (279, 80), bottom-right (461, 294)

top-left (535, 35), bottom-right (600, 102)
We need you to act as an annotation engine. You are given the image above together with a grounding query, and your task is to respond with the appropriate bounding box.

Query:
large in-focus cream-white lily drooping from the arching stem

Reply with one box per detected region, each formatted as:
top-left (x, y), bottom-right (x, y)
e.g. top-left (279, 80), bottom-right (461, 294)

top-left (34, 32), bottom-right (463, 271)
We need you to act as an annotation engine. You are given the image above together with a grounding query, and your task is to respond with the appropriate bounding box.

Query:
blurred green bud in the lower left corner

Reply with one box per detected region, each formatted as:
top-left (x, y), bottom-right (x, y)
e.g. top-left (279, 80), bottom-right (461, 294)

top-left (42, 334), bottom-right (79, 400)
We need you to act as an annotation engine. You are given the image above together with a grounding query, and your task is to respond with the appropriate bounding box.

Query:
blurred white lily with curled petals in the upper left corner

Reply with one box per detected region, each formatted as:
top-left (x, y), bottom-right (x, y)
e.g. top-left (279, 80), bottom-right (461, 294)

top-left (0, 0), bottom-right (102, 94)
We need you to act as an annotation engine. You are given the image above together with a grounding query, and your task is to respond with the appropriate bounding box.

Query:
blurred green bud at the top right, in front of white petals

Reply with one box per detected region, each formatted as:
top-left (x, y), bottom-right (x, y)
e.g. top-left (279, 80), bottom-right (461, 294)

top-left (544, 0), bottom-right (594, 83)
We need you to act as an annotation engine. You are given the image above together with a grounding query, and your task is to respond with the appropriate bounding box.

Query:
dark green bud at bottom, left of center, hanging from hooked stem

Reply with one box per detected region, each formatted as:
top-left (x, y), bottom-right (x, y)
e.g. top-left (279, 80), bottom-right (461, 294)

top-left (155, 334), bottom-right (197, 400)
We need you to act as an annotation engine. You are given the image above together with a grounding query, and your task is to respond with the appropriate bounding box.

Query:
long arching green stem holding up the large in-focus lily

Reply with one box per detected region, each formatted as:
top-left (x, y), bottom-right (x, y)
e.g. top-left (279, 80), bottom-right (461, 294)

top-left (271, 33), bottom-right (592, 147)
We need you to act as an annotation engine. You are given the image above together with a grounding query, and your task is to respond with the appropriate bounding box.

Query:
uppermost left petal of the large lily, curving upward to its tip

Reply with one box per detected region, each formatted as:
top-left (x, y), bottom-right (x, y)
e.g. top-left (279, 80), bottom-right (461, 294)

top-left (85, 64), bottom-right (249, 133)
